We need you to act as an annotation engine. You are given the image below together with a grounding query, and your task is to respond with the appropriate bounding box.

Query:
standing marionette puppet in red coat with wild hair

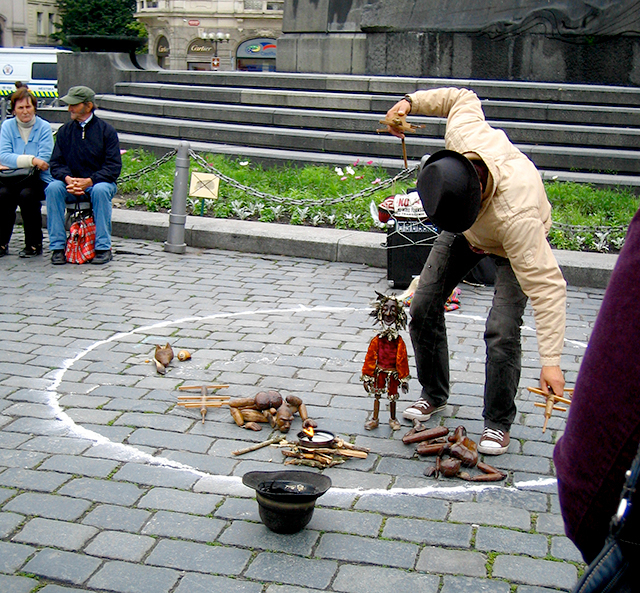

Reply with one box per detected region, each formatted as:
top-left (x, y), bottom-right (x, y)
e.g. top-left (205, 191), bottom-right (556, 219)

top-left (360, 292), bottom-right (411, 430)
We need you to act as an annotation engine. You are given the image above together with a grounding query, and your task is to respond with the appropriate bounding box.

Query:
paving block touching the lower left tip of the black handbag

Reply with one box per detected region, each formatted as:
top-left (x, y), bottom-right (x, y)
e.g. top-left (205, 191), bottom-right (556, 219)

top-left (492, 556), bottom-right (578, 589)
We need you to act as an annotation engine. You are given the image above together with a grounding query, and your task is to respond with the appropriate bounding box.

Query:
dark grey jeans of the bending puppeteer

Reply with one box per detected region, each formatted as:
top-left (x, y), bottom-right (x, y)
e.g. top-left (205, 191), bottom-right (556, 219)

top-left (409, 232), bottom-right (527, 431)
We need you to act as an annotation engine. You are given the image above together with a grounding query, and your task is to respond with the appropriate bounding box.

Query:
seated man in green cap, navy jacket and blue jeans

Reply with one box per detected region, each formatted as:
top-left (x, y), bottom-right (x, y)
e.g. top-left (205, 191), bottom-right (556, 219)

top-left (45, 86), bottom-right (122, 265)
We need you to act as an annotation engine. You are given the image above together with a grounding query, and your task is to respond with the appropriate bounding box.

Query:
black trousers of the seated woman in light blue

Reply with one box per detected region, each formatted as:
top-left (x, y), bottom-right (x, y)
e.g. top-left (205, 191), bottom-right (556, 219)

top-left (0, 178), bottom-right (44, 247)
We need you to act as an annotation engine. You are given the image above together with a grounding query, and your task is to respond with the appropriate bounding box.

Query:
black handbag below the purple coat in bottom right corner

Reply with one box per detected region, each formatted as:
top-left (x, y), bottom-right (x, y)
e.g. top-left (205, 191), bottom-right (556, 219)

top-left (573, 448), bottom-right (640, 593)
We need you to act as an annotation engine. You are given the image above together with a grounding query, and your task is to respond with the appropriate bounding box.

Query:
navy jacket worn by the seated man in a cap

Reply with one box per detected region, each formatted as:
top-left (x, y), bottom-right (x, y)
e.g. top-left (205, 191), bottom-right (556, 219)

top-left (50, 113), bottom-right (122, 185)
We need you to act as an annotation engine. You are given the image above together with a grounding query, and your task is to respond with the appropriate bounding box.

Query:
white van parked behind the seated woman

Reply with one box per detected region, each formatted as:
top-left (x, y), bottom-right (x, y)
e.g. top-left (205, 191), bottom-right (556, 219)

top-left (0, 47), bottom-right (70, 103)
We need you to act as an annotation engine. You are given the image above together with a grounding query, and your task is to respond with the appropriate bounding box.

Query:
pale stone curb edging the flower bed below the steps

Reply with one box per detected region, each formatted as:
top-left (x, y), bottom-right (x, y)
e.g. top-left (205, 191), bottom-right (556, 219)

top-left (112, 208), bottom-right (618, 288)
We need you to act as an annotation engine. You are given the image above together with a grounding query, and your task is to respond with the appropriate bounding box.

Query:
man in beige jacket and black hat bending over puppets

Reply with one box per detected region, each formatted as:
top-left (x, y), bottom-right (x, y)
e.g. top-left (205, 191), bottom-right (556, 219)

top-left (385, 88), bottom-right (566, 455)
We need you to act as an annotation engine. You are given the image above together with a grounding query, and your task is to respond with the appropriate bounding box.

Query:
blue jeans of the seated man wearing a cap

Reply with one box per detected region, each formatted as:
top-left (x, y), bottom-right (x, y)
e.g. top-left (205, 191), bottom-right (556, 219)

top-left (45, 180), bottom-right (116, 251)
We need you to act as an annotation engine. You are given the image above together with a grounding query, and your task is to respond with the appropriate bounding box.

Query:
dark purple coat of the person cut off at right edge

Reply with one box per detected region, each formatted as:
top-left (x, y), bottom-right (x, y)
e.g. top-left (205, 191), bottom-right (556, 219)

top-left (553, 210), bottom-right (640, 562)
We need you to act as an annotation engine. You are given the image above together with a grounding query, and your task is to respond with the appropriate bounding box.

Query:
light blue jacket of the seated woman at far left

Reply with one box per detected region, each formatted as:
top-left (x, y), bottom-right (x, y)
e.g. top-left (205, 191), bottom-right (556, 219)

top-left (0, 115), bottom-right (53, 184)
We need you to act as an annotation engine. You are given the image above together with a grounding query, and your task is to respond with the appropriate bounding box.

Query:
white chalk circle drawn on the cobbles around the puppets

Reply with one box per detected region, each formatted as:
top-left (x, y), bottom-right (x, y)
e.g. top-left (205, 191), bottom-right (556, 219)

top-left (42, 304), bottom-right (586, 496)
